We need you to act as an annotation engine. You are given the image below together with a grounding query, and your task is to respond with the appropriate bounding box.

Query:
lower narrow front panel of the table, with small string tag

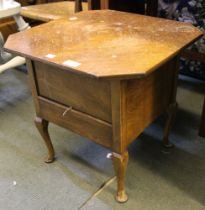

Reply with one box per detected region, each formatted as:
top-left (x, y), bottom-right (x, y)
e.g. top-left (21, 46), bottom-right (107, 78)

top-left (38, 97), bottom-right (112, 148)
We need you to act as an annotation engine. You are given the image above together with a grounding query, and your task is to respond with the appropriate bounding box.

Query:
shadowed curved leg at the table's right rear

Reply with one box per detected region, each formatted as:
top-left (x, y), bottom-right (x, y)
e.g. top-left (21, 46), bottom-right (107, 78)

top-left (163, 102), bottom-right (177, 148)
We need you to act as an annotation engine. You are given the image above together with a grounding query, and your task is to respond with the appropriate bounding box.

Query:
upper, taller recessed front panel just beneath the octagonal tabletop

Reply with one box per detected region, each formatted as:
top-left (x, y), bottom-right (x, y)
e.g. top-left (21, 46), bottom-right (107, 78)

top-left (33, 61), bottom-right (111, 122)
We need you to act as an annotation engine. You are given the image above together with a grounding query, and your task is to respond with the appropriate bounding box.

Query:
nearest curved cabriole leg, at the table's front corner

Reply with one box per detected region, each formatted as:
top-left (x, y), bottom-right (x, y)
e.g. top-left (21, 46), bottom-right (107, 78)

top-left (112, 151), bottom-right (129, 203)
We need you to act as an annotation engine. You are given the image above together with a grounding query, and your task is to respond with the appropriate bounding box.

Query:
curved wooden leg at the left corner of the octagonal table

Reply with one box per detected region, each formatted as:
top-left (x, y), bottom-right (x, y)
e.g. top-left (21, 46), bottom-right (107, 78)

top-left (35, 117), bottom-right (55, 163)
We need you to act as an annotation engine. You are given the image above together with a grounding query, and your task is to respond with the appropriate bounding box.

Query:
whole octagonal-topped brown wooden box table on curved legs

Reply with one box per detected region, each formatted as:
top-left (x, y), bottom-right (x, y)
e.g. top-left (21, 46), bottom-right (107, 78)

top-left (6, 11), bottom-right (202, 202)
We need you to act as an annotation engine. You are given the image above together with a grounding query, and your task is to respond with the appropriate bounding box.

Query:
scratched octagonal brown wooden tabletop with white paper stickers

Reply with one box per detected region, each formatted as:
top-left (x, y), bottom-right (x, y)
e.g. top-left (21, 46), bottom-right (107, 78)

top-left (5, 10), bottom-right (202, 77)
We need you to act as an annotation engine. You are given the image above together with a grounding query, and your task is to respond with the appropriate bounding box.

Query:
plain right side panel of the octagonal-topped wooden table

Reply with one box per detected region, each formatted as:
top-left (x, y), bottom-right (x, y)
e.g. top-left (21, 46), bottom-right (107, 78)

top-left (124, 59), bottom-right (177, 144)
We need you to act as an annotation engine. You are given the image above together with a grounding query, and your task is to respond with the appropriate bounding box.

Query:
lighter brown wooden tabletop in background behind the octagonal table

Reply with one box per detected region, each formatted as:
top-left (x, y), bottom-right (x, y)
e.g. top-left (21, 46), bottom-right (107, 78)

top-left (21, 1), bottom-right (88, 22)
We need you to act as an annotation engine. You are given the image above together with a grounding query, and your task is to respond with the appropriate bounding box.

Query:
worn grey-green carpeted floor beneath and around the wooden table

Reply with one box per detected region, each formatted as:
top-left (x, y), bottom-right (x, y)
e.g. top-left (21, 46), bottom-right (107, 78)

top-left (0, 70), bottom-right (205, 210)
